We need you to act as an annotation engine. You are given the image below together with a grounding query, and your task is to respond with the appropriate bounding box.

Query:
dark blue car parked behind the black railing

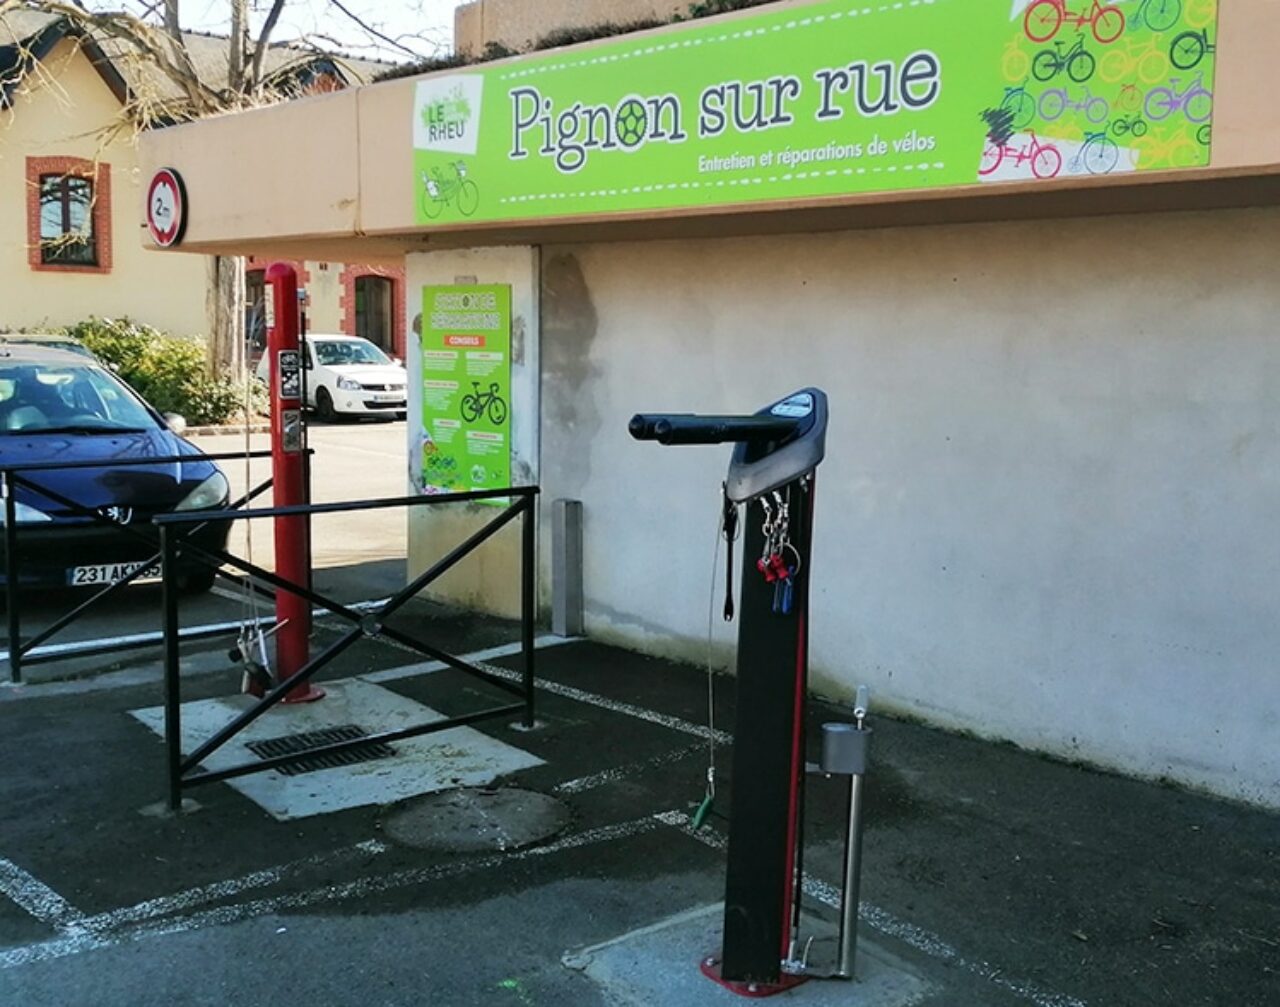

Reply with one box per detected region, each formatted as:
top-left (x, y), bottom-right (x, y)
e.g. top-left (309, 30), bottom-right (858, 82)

top-left (0, 343), bottom-right (230, 592)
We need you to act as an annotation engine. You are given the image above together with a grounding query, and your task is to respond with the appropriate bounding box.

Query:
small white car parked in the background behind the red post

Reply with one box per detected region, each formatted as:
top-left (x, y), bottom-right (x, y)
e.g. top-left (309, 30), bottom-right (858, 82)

top-left (257, 334), bottom-right (408, 420)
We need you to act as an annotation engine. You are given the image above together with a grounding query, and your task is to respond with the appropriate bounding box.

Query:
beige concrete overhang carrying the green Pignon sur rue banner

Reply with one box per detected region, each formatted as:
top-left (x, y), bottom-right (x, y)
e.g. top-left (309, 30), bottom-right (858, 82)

top-left (142, 0), bottom-right (1280, 261)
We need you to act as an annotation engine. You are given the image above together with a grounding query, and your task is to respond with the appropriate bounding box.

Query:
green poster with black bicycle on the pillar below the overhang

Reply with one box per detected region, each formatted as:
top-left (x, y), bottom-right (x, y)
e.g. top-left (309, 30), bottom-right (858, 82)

top-left (420, 284), bottom-right (511, 494)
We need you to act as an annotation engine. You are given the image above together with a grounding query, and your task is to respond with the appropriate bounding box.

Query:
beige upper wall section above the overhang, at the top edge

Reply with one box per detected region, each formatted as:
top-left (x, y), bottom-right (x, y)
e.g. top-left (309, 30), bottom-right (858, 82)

top-left (453, 0), bottom-right (690, 55)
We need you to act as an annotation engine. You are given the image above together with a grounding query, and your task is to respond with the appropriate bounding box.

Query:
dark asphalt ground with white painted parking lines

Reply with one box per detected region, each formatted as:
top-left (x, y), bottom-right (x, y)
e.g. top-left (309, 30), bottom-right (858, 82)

top-left (0, 629), bottom-right (1280, 1007)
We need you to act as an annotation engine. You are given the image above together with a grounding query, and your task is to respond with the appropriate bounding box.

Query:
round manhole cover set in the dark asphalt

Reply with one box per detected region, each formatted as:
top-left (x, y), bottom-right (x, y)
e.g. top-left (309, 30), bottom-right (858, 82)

top-left (383, 787), bottom-right (570, 853)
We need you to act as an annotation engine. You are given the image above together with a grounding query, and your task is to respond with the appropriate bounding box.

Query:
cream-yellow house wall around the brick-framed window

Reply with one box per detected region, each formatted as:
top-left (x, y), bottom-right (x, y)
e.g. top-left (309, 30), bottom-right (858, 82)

top-left (0, 42), bottom-right (207, 334)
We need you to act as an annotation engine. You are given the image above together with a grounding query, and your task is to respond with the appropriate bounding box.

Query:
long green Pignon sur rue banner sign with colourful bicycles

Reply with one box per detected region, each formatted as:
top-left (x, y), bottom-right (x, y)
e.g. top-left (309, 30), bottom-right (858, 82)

top-left (413, 0), bottom-right (1217, 225)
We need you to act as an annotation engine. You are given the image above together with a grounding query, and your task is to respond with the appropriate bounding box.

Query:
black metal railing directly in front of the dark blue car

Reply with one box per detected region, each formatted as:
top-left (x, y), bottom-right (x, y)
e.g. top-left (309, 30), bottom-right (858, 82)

top-left (0, 452), bottom-right (282, 685)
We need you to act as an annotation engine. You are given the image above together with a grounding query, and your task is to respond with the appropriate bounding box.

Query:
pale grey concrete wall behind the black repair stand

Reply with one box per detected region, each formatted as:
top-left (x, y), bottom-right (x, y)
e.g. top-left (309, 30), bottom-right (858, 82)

top-left (543, 210), bottom-right (1280, 805)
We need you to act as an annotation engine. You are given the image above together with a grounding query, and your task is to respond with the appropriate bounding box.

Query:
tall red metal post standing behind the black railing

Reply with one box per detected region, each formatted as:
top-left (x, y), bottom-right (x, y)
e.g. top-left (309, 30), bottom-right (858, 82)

top-left (266, 262), bottom-right (324, 702)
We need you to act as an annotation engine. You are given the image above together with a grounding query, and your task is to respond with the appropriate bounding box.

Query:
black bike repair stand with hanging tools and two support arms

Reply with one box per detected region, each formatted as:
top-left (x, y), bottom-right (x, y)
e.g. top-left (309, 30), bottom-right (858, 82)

top-left (630, 388), bottom-right (827, 995)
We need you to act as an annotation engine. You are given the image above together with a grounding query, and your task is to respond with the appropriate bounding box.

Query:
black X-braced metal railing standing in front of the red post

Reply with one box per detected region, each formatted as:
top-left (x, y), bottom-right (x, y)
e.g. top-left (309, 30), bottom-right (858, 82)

top-left (154, 486), bottom-right (539, 811)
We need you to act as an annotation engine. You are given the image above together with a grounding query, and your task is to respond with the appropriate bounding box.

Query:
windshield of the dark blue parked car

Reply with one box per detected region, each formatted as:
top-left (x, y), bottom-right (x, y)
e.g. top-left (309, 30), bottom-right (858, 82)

top-left (0, 361), bottom-right (156, 435)
